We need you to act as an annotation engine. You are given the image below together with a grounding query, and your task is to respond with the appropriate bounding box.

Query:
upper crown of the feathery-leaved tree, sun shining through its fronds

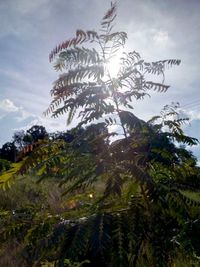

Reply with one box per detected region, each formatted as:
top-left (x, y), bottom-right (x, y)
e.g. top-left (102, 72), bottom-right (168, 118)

top-left (45, 3), bottom-right (180, 137)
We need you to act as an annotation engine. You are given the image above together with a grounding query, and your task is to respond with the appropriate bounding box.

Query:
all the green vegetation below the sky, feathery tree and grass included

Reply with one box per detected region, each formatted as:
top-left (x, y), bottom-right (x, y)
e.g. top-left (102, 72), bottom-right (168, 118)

top-left (0, 4), bottom-right (200, 267)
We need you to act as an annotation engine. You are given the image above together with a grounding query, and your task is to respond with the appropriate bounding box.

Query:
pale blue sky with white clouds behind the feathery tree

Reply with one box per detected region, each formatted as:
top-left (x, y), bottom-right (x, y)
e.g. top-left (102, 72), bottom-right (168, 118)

top-left (0, 0), bottom-right (200, 158)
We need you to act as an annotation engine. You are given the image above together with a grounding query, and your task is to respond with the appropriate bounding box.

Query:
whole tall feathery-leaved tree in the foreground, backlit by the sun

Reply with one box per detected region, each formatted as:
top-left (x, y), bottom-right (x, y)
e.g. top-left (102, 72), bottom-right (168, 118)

top-left (36, 3), bottom-right (199, 266)
